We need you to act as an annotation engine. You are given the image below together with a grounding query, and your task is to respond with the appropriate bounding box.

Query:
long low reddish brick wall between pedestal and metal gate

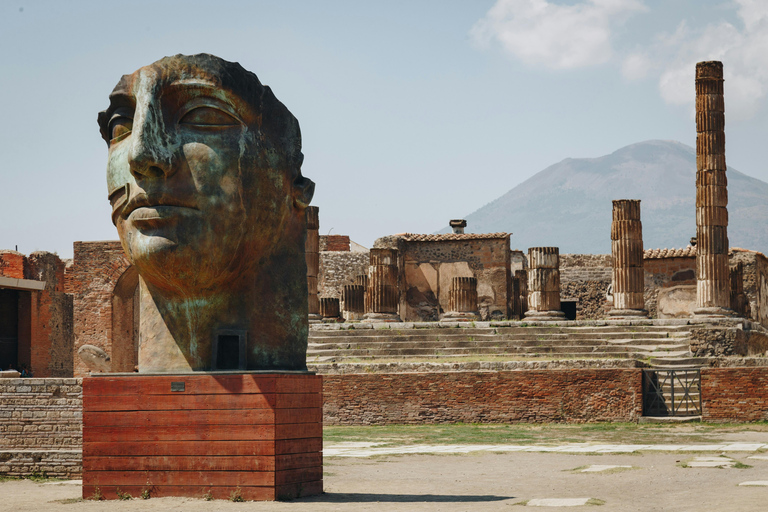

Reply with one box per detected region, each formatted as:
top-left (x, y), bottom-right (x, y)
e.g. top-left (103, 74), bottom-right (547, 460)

top-left (323, 369), bottom-right (642, 425)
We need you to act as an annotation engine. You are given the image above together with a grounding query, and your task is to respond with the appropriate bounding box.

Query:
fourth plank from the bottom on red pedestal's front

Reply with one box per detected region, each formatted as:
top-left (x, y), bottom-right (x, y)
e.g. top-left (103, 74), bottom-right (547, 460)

top-left (83, 439), bottom-right (276, 460)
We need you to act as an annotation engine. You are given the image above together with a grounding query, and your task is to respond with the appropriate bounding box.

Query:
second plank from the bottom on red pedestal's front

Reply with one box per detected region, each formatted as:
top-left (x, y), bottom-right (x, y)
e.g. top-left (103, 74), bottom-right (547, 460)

top-left (83, 470), bottom-right (276, 487)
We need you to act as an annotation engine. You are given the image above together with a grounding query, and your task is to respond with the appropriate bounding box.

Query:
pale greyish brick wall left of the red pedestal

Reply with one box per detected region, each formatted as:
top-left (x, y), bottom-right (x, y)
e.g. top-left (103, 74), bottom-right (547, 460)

top-left (0, 379), bottom-right (83, 478)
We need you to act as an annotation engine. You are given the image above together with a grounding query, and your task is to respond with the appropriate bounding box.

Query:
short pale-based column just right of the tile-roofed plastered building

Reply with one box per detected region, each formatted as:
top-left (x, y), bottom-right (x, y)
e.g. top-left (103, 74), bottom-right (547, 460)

top-left (525, 247), bottom-right (565, 320)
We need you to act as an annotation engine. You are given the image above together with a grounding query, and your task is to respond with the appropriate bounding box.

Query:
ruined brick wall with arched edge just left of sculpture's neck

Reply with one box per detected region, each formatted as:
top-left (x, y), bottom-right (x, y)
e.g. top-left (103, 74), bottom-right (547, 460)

top-left (68, 241), bottom-right (130, 377)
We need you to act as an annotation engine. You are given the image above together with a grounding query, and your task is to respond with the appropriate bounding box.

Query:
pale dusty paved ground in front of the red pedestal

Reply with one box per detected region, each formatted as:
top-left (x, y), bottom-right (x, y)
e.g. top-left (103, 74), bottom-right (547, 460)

top-left (0, 432), bottom-right (768, 512)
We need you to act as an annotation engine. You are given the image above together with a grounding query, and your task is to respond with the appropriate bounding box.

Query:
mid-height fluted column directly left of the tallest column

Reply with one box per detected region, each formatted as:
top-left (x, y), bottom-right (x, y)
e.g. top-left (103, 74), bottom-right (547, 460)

top-left (608, 199), bottom-right (648, 317)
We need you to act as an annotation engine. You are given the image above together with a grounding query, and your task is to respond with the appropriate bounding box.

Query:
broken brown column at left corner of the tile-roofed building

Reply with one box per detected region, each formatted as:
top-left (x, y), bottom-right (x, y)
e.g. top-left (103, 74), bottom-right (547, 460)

top-left (364, 249), bottom-right (400, 322)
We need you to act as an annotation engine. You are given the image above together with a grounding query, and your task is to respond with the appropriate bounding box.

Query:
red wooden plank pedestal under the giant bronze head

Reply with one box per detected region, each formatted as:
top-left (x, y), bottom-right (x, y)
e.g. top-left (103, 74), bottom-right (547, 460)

top-left (83, 373), bottom-right (323, 500)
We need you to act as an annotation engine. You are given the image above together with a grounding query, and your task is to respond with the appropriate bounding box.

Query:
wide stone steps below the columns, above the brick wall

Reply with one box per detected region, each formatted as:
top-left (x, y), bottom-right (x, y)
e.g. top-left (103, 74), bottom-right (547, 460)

top-left (307, 320), bottom-right (700, 368)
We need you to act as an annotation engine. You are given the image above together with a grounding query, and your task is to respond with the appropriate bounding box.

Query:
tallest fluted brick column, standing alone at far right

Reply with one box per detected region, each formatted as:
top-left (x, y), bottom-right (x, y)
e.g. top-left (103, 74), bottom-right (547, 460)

top-left (694, 61), bottom-right (732, 316)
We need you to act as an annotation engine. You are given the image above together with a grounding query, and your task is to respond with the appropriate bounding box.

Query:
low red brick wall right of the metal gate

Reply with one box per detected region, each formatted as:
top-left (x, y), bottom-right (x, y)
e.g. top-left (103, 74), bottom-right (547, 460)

top-left (701, 367), bottom-right (768, 422)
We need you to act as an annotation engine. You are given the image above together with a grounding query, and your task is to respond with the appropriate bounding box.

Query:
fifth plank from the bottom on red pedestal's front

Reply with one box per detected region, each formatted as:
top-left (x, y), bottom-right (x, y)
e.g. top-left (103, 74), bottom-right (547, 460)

top-left (83, 423), bottom-right (278, 444)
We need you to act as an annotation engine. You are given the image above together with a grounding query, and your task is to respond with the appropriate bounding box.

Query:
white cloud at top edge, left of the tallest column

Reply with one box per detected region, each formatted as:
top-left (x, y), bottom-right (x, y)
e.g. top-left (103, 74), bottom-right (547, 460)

top-left (471, 0), bottom-right (645, 69)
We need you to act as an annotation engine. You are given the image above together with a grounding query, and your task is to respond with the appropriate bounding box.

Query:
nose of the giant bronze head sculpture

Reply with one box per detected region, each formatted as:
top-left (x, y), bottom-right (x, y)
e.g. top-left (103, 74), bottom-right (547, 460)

top-left (129, 99), bottom-right (173, 179)
